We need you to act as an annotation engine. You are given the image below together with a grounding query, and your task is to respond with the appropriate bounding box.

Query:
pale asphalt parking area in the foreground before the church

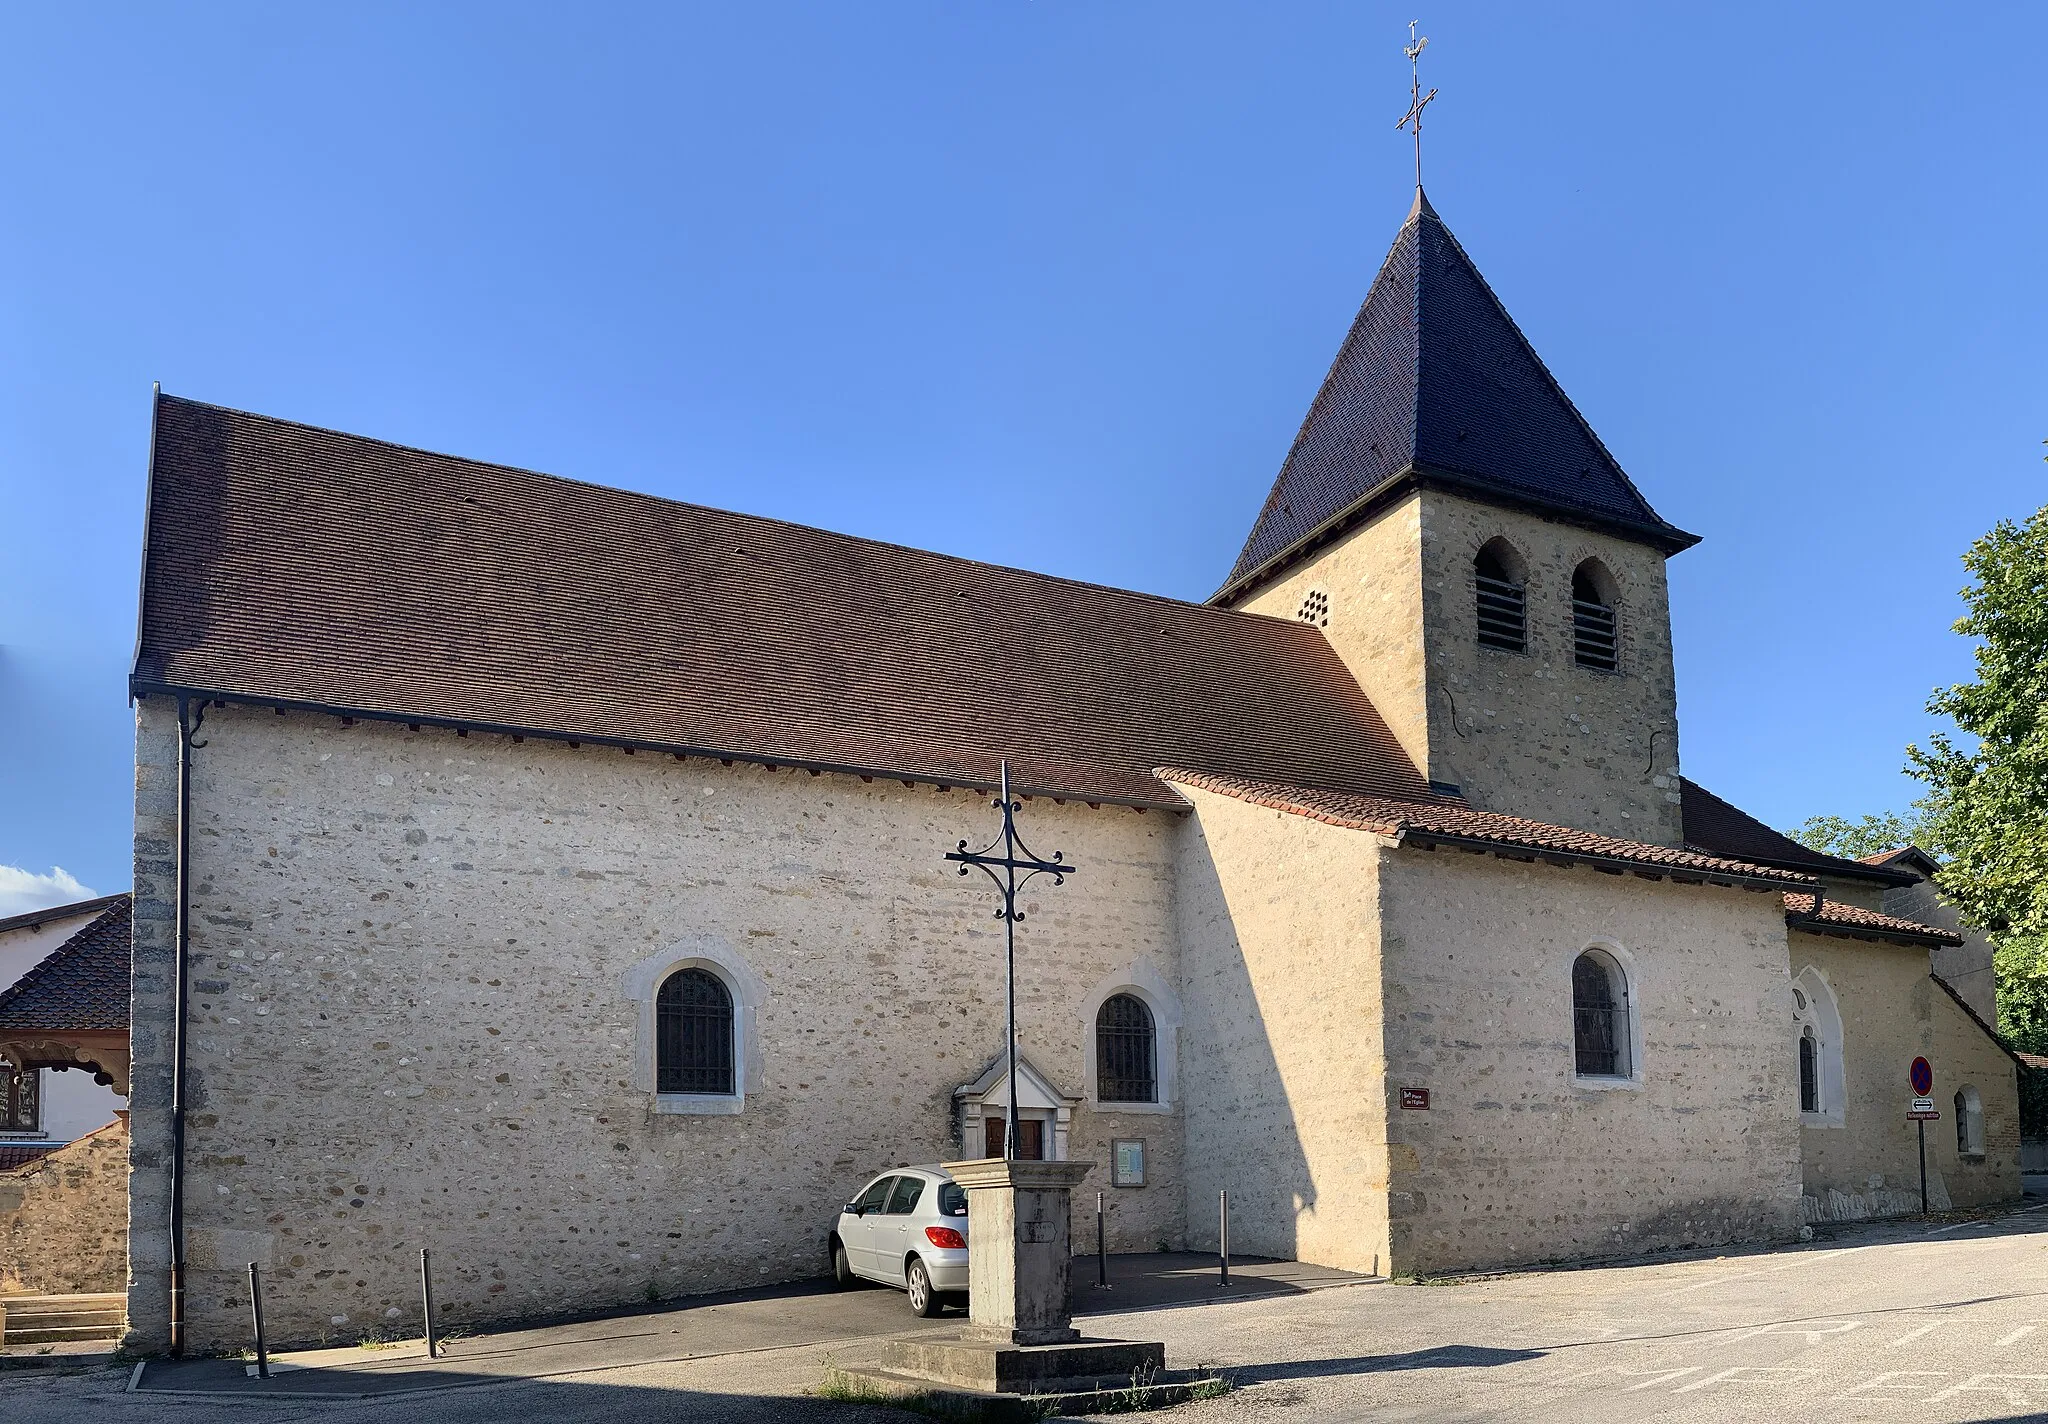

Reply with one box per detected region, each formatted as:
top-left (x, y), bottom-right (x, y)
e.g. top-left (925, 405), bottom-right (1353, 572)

top-left (12, 1205), bottom-right (2048, 1424)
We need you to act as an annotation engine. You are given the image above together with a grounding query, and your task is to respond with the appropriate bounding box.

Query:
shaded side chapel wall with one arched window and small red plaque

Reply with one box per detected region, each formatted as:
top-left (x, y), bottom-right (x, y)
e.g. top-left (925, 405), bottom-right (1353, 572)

top-left (1380, 848), bottom-right (1800, 1274)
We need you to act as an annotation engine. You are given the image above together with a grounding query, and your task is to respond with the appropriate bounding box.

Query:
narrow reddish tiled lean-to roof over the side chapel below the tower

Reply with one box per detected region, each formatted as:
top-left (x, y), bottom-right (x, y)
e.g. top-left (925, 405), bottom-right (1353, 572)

top-left (1159, 766), bottom-right (1812, 885)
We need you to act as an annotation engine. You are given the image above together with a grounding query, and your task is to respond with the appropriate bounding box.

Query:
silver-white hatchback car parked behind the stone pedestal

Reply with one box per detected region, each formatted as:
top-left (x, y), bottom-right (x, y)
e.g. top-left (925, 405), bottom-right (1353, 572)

top-left (825, 1166), bottom-right (967, 1317)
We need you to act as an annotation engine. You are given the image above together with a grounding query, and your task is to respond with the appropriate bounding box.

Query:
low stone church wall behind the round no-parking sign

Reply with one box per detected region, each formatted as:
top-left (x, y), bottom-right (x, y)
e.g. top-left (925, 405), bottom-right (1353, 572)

top-left (1786, 932), bottom-right (2019, 1221)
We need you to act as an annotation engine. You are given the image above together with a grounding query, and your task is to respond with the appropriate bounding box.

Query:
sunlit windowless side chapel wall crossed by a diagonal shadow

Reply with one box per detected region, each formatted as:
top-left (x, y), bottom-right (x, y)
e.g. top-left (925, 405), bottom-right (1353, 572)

top-left (1180, 789), bottom-right (1389, 1272)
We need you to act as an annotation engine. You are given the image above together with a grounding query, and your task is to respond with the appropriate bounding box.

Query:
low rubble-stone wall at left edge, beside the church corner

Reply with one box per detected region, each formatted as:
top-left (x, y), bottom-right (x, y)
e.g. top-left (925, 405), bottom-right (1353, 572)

top-left (0, 1117), bottom-right (129, 1295)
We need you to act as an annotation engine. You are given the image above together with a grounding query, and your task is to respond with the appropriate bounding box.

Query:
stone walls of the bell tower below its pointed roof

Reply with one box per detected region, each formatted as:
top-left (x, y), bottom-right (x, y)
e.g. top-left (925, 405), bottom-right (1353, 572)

top-left (1243, 490), bottom-right (1683, 846)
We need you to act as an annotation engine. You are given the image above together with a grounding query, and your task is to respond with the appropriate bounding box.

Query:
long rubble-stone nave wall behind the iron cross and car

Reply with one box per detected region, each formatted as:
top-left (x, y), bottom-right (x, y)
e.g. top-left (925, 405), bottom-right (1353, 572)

top-left (129, 699), bottom-right (1184, 1350)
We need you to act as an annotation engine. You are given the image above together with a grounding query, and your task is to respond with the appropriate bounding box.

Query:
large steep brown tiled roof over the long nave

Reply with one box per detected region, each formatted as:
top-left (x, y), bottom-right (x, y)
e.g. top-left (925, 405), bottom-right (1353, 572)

top-left (133, 395), bottom-right (1430, 805)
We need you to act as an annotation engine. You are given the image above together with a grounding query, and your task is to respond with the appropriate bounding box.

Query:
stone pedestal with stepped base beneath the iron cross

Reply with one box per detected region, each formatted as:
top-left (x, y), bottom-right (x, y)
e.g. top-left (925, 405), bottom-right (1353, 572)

top-left (883, 1158), bottom-right (1165, 1393)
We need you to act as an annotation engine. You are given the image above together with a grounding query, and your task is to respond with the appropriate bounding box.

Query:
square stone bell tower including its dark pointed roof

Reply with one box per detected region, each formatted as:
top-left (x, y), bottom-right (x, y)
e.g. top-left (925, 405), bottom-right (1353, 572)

top-left (1210, 189), bottom-right (1698, 844)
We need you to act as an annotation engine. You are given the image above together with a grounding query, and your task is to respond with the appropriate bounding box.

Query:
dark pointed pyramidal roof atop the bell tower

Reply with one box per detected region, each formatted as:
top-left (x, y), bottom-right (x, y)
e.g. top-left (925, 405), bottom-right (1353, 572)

top-left (1214, 189), bottom-right (1698, 602)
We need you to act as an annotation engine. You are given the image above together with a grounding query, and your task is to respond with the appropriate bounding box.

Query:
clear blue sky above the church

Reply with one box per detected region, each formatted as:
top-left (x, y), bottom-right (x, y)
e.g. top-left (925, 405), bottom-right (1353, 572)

top-left (0, 0), bottom-right (2048, 904)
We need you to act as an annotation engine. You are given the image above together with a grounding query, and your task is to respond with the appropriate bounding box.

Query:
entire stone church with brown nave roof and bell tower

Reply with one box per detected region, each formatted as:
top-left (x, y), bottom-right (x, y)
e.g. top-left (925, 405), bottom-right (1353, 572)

top-left (129, 191), bottom-right (2019, 1350)
